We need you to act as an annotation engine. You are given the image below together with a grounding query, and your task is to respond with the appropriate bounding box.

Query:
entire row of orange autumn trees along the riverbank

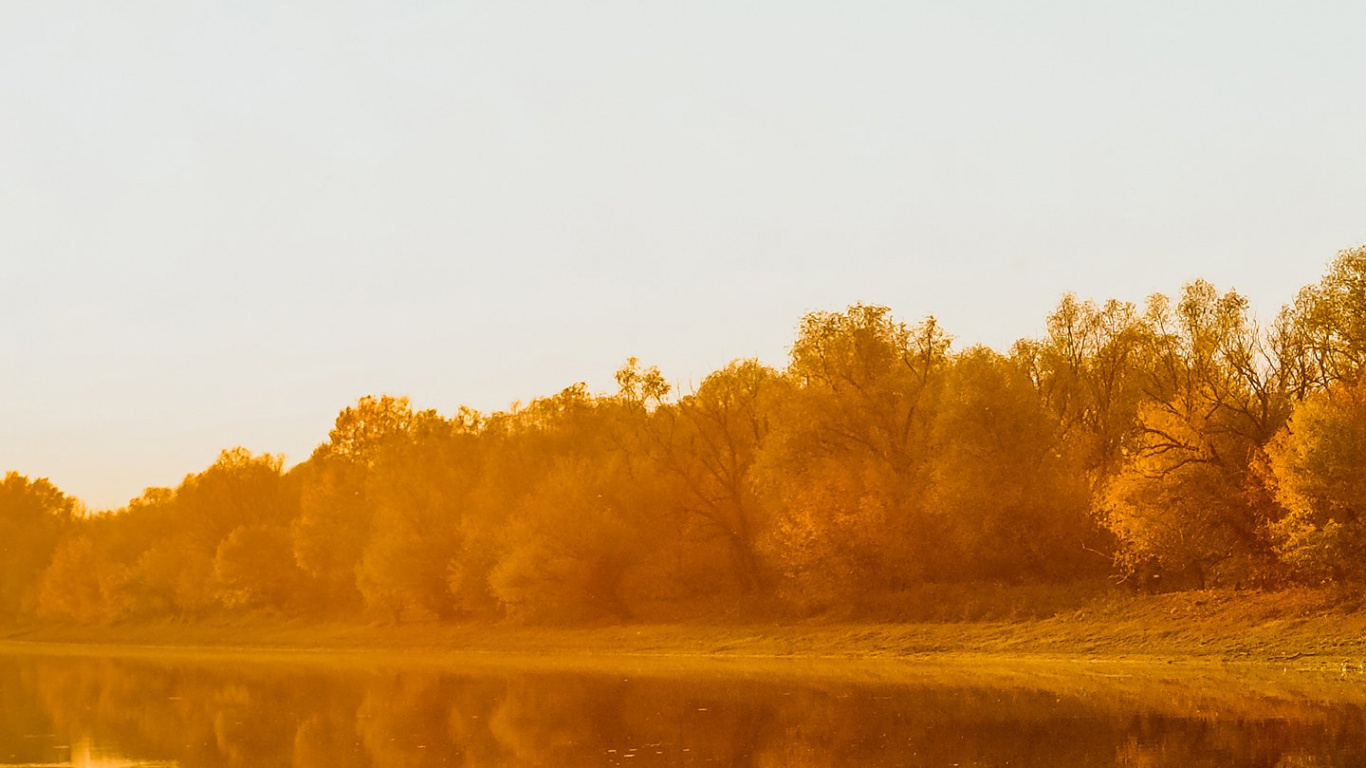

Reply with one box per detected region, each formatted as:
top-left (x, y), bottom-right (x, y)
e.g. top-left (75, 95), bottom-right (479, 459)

top-left (0, 247), bottom-right (1366, 622)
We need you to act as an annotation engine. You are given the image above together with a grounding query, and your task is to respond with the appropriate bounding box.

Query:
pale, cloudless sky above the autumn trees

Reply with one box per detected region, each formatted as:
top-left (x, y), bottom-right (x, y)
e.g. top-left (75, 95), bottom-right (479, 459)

top-left (0, 0), bottom-right (1366, 508)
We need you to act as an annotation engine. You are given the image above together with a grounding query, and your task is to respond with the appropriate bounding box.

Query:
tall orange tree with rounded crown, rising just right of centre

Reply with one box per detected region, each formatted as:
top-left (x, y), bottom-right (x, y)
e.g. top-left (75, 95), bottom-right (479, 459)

top-left (755, 305), bottom-right (949, 604)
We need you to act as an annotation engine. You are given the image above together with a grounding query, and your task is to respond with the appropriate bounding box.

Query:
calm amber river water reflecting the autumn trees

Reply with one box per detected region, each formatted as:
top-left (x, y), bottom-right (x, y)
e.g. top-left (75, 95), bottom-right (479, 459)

top-left (0, 647), bottom-right (1366, 768)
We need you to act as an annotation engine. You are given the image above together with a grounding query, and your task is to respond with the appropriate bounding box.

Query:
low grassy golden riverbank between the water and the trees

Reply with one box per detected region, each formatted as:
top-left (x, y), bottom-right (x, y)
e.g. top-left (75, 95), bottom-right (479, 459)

top-left (0, 589), bottom-right (1366, 671)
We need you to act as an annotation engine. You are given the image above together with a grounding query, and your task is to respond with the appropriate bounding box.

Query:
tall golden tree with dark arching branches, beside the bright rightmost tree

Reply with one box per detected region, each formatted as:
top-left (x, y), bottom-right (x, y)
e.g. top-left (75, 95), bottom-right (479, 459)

top-left (1100, 282), bottom-right (1291, 585)
